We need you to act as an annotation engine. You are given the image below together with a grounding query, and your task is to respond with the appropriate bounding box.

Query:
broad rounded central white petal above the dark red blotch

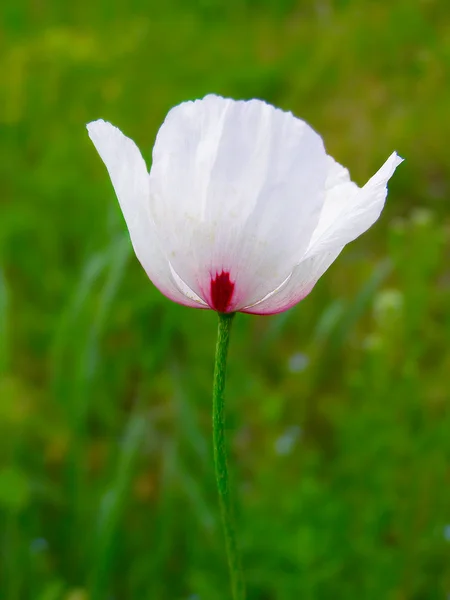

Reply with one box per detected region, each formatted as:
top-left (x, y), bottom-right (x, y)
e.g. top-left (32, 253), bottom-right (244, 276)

top-left (150, 96), bottom-right (327, 310)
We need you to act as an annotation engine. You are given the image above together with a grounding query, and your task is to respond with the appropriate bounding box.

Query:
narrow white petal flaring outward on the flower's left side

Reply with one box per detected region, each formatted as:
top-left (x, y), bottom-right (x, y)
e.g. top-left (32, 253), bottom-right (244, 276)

top-left (87, 120), bottom-right (206, 307)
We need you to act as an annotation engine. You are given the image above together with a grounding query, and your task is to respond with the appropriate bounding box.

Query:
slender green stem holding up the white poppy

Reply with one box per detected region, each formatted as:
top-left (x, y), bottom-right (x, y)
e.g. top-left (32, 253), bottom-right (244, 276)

top-left (213, 313), bottom-right (245, 600)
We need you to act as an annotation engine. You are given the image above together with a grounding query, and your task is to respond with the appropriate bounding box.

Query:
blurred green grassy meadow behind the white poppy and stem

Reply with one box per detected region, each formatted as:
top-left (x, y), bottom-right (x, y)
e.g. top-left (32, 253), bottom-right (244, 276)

top-left (0, 0), bottom-right (450, 600)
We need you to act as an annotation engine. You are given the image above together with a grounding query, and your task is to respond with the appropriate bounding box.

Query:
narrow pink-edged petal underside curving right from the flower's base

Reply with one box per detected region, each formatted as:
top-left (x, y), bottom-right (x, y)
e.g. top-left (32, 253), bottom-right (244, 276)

top-left (242, 246), bottom-right (343, 315)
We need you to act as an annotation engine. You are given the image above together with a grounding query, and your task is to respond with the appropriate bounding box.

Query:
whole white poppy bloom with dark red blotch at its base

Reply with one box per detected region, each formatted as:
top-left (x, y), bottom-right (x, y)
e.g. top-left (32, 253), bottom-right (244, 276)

top-left (87, 95), bottom-right (402, 314)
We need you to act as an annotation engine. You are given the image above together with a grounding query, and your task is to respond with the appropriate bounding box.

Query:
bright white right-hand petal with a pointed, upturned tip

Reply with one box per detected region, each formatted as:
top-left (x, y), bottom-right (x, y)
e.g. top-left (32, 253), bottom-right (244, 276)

top-left (306, 152), bottom-right (403, 256)
